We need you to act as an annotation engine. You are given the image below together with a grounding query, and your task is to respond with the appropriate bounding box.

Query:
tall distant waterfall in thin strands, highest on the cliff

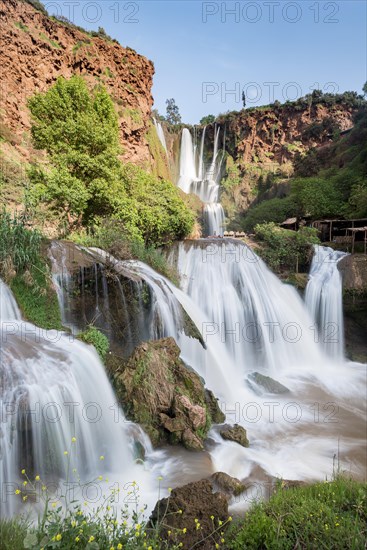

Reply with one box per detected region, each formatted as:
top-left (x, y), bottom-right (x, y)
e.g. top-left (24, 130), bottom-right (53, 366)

top-left (177, 128), bottom-right (225, 236)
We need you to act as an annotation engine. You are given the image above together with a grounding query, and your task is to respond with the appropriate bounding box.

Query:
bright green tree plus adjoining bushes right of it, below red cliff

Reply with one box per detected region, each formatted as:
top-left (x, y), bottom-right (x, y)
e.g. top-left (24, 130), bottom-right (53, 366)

top-left (29, 76), bottom-right (194, 246)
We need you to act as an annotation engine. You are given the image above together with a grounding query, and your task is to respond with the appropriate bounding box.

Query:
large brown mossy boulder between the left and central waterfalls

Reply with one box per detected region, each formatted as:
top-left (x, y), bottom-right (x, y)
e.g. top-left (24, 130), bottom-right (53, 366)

top-left (107, 338), bottom-right (224, 450)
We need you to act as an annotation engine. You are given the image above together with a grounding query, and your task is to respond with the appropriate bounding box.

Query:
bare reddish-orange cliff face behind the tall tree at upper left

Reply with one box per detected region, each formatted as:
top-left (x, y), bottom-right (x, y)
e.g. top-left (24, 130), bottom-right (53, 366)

top-left (0, 0), bottom-right (154, 169)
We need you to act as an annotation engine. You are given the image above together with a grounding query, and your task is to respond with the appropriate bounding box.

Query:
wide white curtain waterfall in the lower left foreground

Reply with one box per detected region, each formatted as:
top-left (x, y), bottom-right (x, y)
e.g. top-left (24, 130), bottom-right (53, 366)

top-left (0, 282), bottom-right (156, 515)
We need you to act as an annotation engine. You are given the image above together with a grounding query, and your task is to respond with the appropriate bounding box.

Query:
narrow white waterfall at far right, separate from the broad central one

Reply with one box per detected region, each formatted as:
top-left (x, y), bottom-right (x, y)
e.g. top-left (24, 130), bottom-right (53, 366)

top-left (305, 245), bottom-right (346, 360)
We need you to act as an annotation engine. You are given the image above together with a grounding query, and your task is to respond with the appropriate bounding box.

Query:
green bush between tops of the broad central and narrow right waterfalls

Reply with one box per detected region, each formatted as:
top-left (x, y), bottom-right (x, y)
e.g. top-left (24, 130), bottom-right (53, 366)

top-left (255, 222), bottom-right (320, 272)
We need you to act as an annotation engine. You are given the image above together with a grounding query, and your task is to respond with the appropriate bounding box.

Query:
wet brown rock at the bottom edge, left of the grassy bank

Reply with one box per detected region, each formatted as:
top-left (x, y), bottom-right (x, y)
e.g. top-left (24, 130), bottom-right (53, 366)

top-left (150, 480), bottom-right (229, 550)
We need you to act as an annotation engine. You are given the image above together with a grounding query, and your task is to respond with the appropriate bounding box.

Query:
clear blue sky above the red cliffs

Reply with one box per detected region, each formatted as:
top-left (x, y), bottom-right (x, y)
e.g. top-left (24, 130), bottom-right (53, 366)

top-left (44, 0), bottom-right (367, 123)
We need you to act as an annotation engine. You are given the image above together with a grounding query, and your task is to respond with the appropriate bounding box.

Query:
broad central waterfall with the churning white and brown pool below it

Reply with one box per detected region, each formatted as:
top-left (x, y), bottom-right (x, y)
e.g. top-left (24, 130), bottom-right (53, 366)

top-left (170, 239), bottom-right (366, 487)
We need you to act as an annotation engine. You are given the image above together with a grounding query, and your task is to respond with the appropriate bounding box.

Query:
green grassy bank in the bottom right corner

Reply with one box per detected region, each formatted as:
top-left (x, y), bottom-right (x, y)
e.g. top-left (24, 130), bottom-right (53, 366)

top-left (227, 477), bottom-right (367, 550)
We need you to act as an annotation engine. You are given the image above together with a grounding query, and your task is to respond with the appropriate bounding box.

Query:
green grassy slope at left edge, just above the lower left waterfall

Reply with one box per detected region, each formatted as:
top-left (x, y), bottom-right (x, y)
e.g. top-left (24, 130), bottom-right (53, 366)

top-left (0, 211), bottom-right (62, 329)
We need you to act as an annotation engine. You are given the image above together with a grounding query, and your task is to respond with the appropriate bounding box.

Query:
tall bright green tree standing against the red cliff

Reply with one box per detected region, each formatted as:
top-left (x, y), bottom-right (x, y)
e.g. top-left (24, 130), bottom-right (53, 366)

top-left (28, 76), bottom-right (124, 225)
